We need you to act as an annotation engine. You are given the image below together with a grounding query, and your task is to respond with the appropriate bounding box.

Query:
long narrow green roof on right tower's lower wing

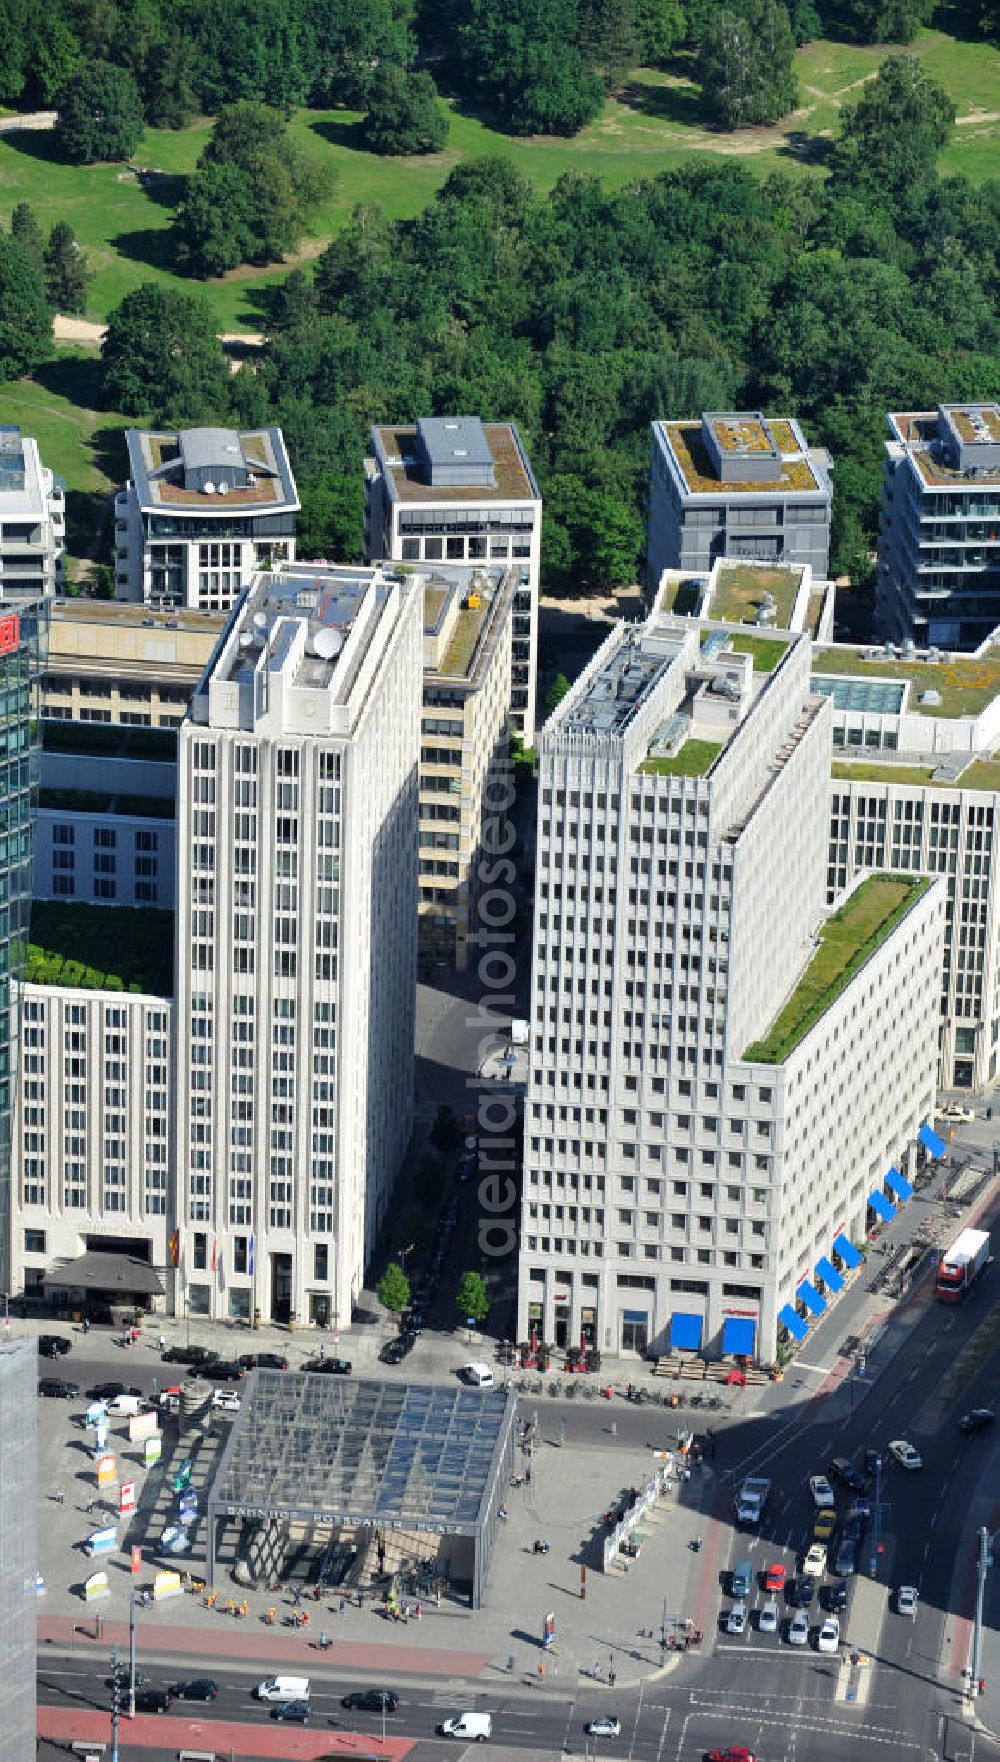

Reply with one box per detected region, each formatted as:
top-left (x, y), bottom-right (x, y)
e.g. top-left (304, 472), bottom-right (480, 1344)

top-left (743, 874), bottom-right (930, 1064)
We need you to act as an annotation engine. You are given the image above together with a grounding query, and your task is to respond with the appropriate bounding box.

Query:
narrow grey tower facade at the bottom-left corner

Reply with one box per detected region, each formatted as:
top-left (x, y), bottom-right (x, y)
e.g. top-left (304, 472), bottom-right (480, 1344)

top-left (0, 1339), bottom-right (39, 1762)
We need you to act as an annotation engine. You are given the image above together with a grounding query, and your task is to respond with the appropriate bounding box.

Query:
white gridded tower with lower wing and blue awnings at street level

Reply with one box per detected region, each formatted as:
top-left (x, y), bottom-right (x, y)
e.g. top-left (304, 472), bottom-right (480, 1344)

top-left (518, 613), bottom-right (944, 1359)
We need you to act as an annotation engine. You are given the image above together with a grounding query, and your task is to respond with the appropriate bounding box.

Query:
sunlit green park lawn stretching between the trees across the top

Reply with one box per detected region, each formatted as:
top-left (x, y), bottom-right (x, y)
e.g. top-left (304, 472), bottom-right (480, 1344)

top-left (0, 32), bottom-right (1000, 329)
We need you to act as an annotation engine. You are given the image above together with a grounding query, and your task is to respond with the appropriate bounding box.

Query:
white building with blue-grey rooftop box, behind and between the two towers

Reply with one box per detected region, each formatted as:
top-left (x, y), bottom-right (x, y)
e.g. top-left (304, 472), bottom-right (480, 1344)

top-left (364, 416), bottom-right (542, 745)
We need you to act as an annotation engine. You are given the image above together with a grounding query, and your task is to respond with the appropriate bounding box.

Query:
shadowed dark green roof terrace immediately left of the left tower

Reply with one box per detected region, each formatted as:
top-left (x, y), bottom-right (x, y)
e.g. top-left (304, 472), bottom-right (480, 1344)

top-left (25, 900), bottom-right (174, 997)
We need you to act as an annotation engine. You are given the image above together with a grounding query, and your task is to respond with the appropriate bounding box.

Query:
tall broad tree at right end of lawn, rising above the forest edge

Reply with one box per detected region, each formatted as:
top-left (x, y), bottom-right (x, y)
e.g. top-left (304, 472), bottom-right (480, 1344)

top-left (831, 55), bottom-right (954, 208)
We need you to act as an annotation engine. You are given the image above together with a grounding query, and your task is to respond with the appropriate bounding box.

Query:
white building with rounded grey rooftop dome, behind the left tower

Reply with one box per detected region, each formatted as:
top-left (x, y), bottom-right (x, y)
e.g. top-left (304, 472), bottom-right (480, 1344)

top-left (114, 428), bottom-right (301, 613)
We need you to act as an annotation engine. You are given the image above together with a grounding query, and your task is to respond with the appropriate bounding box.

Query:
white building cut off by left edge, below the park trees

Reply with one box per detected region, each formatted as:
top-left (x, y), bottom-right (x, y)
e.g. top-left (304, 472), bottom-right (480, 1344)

top-left (0, 425), bottom-right (65, 604)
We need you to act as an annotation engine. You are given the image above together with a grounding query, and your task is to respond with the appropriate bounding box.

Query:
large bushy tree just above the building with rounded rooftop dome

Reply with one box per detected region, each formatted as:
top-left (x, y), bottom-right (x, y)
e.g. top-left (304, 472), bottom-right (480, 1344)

top-left (100, 282), bottom-right (229, 425)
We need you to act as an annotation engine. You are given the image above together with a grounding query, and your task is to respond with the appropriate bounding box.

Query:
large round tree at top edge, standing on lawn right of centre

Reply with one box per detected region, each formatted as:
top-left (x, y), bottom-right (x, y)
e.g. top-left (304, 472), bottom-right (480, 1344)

top-left (697, 0), bottom-right (798, 129)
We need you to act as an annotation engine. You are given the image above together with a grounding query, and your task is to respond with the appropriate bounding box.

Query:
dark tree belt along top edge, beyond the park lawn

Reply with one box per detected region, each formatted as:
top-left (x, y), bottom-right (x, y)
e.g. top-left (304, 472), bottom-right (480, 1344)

top-left (0, 0), bottom-right (1000, 135)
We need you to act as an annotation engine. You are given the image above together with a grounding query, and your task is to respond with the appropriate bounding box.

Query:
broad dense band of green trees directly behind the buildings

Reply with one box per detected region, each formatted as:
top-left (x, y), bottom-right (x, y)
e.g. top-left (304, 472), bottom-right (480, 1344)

top-left (72, 56), bottom-right (1000, 590)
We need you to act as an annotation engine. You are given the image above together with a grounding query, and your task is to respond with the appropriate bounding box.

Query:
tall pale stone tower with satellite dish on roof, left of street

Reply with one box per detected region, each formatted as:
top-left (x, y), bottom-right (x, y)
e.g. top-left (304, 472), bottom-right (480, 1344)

top-left (176, 567), bottom-right (417, 1327)
